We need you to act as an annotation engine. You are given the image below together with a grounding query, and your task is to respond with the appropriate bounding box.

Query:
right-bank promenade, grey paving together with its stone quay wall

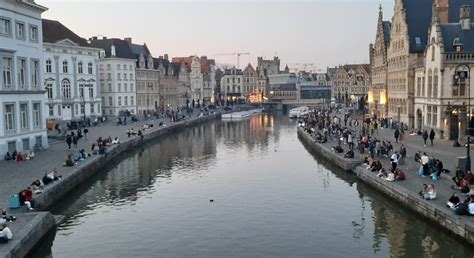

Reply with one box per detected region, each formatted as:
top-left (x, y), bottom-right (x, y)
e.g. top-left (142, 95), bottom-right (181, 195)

top-left (298, 111), bottom-right (474, 244)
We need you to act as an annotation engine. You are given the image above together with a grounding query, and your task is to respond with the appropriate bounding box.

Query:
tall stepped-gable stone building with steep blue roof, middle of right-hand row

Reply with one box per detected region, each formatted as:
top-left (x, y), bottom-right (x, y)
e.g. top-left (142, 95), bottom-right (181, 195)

top-left (387, 0), bottom-right (433, 128)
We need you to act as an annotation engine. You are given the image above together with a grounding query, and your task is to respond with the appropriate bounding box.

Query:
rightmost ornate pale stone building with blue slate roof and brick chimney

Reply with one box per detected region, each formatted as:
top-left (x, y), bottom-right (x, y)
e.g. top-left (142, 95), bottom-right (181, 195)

top-left (415, 0), bottom-right (474, 141)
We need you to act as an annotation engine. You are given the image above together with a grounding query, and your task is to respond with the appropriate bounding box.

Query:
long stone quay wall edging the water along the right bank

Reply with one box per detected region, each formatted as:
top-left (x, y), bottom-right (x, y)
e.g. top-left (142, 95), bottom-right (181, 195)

top-left (298, 128), bottom-right (474, 245)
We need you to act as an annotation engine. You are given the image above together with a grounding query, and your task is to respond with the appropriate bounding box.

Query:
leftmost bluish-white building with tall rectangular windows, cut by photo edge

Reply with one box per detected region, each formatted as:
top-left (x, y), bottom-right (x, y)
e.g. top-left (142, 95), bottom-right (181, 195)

top-left (0, 0), bottom-right (48, 157)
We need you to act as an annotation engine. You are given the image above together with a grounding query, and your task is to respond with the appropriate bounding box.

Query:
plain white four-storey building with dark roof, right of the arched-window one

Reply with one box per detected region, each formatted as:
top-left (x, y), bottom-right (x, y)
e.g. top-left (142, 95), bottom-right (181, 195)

top-left (90, 37), bottom-right (137, 116)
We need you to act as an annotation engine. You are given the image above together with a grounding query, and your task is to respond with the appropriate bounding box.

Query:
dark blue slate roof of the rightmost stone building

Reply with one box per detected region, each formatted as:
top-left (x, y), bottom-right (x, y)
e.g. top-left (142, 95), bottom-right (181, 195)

top-left (440, 23), bottom-right (474, 53)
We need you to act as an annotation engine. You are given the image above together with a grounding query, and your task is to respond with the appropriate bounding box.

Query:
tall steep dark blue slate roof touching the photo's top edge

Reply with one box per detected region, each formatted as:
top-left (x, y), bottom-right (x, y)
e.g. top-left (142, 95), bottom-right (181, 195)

top-left (403, 0), bottom-right (434, 53)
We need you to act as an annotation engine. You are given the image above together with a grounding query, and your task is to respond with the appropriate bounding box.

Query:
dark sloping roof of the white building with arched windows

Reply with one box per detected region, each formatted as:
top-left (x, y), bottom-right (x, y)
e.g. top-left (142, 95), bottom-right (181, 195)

top-left (42, 19), bottom-right (90, 47)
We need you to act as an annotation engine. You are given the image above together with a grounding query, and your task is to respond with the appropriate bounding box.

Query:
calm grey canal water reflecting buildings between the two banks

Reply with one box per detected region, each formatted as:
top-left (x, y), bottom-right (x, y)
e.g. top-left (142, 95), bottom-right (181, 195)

top-left (30, 114), bottom-right (474, 257)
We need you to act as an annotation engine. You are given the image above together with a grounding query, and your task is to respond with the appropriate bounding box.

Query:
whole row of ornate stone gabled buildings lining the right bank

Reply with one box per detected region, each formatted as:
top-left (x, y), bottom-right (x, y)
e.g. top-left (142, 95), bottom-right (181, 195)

top-left (369, 0), bottom-right (474, 140)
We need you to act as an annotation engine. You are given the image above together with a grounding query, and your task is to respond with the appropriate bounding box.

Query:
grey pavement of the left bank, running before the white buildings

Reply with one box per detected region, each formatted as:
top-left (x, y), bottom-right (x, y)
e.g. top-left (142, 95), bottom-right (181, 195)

top-left (0, 109), bottom-right (225, 214)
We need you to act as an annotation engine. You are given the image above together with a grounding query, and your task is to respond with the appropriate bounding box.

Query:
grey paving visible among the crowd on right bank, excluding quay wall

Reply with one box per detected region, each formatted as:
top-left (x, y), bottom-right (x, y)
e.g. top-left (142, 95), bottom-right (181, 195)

top-left (326, 109), bottom-right (474, 226)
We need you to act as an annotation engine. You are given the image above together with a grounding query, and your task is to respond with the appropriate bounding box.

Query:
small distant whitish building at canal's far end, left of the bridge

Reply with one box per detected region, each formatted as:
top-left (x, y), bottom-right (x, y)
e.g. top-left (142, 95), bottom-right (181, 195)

top-left (221, 67), bottom-right (244, 101)
